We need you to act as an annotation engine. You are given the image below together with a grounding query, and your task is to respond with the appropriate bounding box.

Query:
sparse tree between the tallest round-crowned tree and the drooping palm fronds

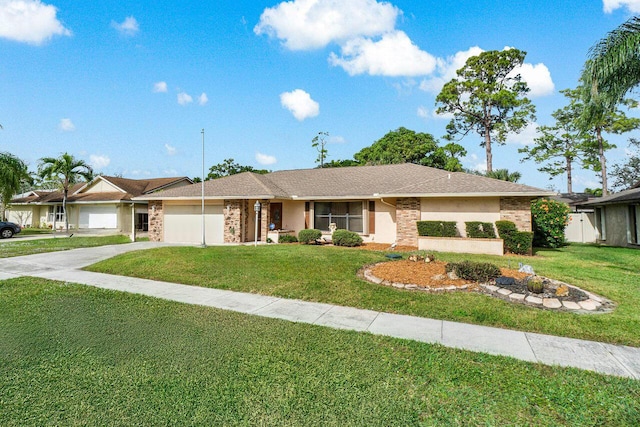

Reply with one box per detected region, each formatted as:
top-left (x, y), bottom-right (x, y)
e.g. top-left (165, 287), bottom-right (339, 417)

top-left (518, 89), bottom-right (589, 193)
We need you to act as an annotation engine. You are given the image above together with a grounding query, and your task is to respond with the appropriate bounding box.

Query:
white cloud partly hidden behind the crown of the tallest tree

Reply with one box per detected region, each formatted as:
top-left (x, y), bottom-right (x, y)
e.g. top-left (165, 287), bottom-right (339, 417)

top-left (420, 46), bottom-right (555, 98)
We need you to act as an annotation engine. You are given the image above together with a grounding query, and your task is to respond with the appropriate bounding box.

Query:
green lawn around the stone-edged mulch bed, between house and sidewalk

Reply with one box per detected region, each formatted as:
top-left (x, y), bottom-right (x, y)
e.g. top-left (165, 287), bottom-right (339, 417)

top-left (88, 245), bottom-right (640, 346)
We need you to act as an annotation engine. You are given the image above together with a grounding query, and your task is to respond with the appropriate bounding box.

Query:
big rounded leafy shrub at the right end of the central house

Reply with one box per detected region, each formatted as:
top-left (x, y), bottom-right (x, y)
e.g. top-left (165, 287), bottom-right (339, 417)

top-left (531, 199), bottom-right (571, 248)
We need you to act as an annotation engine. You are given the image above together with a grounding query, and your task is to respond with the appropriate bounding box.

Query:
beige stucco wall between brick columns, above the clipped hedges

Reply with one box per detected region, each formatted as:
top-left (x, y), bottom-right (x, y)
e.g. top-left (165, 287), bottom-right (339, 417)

top-left (420, 197), bottom-right (501, 237)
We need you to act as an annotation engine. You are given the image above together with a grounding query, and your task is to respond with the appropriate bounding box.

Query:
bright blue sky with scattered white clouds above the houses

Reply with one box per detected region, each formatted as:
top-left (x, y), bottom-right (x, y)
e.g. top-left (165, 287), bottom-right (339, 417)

top-left (0, 0), bottom-right (640, 191)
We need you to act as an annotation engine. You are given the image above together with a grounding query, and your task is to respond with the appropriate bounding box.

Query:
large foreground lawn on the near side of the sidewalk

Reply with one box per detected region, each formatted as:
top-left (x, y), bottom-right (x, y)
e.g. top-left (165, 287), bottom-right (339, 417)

top-left (0, 280), bottom-right (640, 426)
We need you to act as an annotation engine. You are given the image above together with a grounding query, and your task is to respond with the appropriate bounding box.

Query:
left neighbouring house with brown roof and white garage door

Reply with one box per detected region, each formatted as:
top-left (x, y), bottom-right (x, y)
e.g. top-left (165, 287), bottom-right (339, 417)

top-left (6, 176), bottom-right (193, 233)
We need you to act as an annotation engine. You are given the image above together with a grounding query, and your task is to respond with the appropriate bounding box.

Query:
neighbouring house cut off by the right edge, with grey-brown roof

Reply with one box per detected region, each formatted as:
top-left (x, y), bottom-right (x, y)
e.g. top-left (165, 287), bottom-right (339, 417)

top-left (580, 182), bottom-right (640, 248)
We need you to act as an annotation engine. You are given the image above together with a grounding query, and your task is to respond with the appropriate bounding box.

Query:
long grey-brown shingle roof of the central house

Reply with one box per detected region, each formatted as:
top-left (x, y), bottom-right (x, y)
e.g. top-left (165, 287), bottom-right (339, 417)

top-left (139, 163), bottom-right (555, 200)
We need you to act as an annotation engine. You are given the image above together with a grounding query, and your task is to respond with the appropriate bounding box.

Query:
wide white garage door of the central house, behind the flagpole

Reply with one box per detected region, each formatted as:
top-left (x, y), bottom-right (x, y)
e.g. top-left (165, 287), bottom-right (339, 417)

top-left (164, 205), bottom-right (224, 244)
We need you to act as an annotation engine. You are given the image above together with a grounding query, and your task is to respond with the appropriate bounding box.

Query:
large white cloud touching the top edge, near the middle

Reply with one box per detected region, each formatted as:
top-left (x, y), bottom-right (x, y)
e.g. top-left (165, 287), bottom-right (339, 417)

top-left (253, 0), bottom-right (402, 50)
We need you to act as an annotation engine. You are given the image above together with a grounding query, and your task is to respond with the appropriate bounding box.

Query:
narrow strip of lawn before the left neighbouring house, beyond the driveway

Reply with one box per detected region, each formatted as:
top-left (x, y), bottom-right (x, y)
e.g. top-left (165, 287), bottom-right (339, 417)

top-left (0, 236), bottom-right (131, 258)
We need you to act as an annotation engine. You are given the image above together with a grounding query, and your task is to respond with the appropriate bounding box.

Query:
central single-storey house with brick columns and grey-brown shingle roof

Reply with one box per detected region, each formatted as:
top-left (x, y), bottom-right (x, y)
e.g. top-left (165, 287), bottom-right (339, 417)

top-left (134, 164), bottom-right (555, 251)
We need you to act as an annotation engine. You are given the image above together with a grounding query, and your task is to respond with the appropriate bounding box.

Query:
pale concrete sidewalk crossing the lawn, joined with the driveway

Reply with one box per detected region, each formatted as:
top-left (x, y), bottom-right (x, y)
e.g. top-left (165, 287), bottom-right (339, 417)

top-left (0, 242), bottom-right (640, 380)
